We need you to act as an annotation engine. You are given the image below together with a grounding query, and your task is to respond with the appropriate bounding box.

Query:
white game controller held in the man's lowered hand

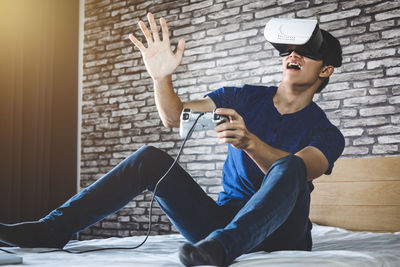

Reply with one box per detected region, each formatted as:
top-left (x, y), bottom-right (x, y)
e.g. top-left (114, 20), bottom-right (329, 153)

top-left (179, 108), bottom-right (229, 138)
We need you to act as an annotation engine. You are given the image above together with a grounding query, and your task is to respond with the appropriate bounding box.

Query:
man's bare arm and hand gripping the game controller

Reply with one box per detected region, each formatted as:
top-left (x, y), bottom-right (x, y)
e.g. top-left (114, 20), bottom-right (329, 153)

top-left (215, 108), bottom-right (329, 181)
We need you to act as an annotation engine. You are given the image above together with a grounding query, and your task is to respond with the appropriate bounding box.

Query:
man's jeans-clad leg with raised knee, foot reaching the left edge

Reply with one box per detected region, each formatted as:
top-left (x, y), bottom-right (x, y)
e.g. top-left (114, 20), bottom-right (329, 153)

top-left (0, 146), bottom-right (234, 247)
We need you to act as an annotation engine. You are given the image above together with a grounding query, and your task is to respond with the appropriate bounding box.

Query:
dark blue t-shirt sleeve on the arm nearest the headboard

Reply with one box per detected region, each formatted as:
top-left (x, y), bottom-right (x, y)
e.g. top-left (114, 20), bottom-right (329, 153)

top-left (308, 122), bottom-right (345, 174)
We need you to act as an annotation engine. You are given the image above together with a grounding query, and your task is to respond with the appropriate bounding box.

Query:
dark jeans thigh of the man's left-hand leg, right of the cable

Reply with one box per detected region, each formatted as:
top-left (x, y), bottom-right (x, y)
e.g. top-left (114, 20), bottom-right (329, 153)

top-left (156, 166), bottom-right (240, 246)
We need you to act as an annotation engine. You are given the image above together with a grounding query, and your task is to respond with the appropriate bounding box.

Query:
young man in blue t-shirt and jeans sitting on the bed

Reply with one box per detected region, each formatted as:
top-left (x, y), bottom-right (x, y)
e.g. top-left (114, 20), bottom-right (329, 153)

top-left (0, 13), bottom-right (344, 266)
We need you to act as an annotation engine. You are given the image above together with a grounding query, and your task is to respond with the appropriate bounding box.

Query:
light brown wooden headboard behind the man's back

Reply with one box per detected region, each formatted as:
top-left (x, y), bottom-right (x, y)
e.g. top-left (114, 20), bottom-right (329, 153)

top-left (310, 157), bottom-right (400, 232)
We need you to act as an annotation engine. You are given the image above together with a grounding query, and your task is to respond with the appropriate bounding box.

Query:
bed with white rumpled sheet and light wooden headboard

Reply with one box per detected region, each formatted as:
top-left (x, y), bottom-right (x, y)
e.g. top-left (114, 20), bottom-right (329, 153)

top-left (0, 157), bottom-right (400, 267)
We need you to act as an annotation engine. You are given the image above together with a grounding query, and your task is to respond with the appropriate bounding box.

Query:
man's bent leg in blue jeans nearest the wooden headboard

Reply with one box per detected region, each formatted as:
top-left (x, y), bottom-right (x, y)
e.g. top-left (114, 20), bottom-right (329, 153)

top-left (181, 155), bottom-right (311, 266)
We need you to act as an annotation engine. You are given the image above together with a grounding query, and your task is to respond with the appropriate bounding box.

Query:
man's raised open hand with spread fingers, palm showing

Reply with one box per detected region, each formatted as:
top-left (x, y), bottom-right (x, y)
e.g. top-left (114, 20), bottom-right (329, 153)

top-left (129, 13), bottom-right (185, 80)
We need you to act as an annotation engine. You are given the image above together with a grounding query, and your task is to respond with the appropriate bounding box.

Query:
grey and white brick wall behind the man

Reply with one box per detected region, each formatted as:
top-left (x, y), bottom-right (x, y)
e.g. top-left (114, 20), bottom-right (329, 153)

top-left (80, 0), bottom-right (400, 239)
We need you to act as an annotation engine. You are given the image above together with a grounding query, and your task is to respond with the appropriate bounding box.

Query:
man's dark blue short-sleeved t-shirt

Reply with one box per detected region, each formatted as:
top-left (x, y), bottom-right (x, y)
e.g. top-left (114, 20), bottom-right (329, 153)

top-left (207, 85), bottom-right (344, 205)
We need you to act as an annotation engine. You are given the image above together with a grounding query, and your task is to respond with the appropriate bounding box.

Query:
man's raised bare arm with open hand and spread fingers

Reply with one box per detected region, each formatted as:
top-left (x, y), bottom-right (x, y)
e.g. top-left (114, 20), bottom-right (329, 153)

top-left (129, 13), bottom-right (215, 128)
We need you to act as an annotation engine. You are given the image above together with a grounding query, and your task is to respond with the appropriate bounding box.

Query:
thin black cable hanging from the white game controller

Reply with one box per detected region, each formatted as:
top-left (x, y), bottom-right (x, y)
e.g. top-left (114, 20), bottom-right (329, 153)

top-left (35, 112), bottom-right (204, 254)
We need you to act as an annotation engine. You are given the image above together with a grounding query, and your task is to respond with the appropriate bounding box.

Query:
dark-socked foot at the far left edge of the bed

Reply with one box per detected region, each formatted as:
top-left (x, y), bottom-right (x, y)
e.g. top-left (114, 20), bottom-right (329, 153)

top-left (0, 221), bottom-right (66, 248)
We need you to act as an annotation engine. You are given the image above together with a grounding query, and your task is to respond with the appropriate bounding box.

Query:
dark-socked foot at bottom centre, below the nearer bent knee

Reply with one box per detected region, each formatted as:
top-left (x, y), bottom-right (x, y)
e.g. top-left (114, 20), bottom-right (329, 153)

top-left (179, 239), bottom-right (225, 266)
